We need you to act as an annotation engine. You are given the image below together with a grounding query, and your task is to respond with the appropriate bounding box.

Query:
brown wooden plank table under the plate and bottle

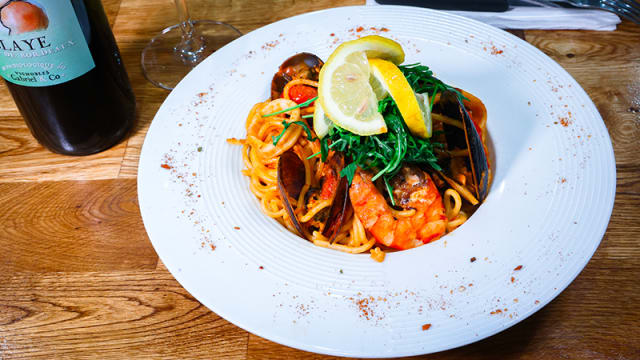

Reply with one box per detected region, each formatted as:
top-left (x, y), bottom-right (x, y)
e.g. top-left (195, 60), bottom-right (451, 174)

top-left (0, 0), bottom-right (640, 359)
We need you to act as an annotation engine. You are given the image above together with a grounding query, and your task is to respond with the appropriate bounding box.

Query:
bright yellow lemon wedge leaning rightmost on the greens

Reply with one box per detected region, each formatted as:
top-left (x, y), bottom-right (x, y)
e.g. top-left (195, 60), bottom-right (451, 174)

top-left (369, 59), bottom-right (431, 138)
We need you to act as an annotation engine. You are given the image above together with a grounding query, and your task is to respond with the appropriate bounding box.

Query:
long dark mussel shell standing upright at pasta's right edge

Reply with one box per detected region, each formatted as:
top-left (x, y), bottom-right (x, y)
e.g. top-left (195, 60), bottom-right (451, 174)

top-left (438, 91), bottom-right (489, 202)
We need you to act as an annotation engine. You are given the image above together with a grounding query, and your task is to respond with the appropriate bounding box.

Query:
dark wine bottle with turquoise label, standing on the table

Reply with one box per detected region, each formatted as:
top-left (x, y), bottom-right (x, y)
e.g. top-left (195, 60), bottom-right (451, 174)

top-left (0, 0), bottom-right (135, 155)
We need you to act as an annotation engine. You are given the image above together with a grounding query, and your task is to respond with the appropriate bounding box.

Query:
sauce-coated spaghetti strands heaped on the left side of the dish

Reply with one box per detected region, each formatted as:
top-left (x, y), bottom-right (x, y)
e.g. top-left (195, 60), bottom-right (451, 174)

top-left (239, 80), bottom-right (375, 253)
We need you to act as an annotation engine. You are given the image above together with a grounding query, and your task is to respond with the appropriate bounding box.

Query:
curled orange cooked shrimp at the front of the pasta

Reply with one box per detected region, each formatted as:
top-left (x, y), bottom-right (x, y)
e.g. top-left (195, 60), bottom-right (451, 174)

top-left (349, 166), bottom-right (447, 250)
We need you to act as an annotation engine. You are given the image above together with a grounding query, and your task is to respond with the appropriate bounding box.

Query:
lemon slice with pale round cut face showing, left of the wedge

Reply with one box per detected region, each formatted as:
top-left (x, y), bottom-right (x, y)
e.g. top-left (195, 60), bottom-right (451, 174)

top-left (314, 35), bottom-right (404, 136)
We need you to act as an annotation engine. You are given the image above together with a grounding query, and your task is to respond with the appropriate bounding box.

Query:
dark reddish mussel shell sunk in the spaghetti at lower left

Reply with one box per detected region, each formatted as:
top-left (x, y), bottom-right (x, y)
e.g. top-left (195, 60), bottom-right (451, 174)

top-left (278, 150), bottom-right (305, 237)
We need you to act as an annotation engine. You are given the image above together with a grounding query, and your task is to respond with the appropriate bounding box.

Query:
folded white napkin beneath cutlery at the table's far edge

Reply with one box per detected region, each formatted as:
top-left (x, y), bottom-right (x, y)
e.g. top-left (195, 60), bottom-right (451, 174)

top-left (367, 0), bottom-right (620, 31)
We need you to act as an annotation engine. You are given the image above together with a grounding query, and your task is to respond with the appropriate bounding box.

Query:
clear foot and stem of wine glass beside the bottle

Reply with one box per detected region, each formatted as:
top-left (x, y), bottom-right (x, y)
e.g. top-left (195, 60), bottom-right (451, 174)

top-left (141, 0), bottom-right (242, 90)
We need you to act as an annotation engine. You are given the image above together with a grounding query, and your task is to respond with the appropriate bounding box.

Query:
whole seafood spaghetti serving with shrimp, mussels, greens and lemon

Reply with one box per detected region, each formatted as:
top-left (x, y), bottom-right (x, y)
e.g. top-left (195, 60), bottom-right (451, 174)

top-left (229, 35), bottom-right (491, 261)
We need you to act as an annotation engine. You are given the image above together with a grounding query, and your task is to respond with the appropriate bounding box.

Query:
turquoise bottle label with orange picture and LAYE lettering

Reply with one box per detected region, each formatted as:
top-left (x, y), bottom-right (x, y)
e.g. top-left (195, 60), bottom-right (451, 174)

top-left (0, 0), bottom-right (95, 86)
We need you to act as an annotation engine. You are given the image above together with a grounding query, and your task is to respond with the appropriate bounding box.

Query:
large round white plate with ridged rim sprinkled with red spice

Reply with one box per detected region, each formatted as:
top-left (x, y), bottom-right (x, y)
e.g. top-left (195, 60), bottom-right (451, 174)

top-left (138, 6), bottom-right (616, 357)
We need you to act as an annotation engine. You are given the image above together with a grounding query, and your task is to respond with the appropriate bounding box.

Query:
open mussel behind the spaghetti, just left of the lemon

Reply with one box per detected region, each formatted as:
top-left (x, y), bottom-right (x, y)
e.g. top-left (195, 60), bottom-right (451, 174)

top-left (271, 52), bottom-right (324, 100)
